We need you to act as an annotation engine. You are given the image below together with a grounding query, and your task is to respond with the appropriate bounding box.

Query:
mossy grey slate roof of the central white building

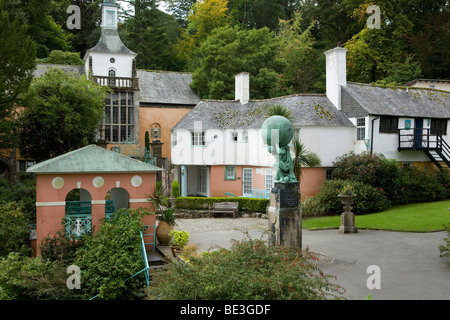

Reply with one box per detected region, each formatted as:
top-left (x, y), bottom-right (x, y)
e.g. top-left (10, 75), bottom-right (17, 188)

top-left (172, 94), bottom-right (354, 131)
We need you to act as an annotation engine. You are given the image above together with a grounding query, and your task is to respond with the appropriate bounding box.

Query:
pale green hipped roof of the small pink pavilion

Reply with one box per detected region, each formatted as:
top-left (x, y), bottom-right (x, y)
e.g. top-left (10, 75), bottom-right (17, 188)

top-left (27, 145), bottom-right (163, 173)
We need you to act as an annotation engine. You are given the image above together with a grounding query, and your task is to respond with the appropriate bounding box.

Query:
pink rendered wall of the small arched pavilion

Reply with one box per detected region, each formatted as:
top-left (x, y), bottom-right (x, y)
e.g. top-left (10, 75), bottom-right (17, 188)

top-left (36, 173), bottom-right (156, 255)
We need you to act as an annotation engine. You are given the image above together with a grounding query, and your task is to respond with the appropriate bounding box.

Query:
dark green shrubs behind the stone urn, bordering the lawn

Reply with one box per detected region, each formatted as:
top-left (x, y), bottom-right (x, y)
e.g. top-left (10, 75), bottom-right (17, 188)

top-left (302, 152), bottom-right (450, 216)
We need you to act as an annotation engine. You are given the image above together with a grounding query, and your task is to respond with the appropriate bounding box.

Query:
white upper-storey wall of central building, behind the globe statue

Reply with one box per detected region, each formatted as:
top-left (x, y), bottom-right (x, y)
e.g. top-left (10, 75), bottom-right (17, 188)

top-left (171, 127), bottom-right (355, 167)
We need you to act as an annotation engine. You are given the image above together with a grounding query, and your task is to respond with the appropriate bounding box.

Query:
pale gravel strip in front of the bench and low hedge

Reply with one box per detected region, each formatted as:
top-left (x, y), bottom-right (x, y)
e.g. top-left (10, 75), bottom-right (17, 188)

top-left (175, 218), bottom-right (268, 234)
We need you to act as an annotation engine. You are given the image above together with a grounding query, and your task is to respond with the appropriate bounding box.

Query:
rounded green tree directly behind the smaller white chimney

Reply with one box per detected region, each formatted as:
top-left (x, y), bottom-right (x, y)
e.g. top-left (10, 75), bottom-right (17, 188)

top-left (191, 26), bottom-right (285, 99)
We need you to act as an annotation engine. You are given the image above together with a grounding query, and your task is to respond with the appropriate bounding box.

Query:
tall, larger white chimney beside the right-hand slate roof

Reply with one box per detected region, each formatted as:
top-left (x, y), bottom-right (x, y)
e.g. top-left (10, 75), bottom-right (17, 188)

top-left (325, 47), bottom-right (347, 110)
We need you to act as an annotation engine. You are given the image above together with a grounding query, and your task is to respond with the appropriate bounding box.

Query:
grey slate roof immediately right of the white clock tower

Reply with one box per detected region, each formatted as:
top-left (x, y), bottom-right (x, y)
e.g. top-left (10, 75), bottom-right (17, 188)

top-left (137, 70), bottom-right (200, 106)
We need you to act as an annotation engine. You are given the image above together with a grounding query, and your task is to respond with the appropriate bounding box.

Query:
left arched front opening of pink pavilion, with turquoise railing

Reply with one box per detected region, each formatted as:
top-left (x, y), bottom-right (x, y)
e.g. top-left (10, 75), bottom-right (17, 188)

top-left (64, 189), bottom-right (92, 238)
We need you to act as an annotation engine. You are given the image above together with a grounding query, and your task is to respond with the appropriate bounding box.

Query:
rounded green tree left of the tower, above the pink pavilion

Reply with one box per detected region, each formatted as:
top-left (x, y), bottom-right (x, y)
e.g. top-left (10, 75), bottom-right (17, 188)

top-left (18, 68), bottom-right (108, 161)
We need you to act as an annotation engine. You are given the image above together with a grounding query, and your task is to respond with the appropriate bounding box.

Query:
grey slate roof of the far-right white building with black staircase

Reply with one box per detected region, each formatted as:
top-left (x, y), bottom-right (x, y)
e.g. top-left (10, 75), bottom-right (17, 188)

top-left (342, 82), bottom-right (450, 118)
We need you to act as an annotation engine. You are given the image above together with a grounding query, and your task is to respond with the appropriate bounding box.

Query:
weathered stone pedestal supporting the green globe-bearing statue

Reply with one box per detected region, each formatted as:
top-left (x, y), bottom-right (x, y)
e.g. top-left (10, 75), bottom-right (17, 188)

top-left (267, 182), bottom-right (302, 249)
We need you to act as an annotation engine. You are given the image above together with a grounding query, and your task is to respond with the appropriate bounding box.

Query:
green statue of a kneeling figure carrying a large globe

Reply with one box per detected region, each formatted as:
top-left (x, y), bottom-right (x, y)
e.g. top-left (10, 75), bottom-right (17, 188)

top-left (261, 116), bottom-right (298, 183)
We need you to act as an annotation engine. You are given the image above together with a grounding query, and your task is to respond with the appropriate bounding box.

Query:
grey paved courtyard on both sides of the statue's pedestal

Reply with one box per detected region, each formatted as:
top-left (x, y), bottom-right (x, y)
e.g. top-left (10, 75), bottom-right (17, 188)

top-left (177, 218), bottom-right (450, 300)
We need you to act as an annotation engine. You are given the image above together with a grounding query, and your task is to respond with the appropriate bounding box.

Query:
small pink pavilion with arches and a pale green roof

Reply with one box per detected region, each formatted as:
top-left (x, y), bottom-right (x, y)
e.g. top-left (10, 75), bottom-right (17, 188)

top-left (27, 145), bottom-right (162, 255)
